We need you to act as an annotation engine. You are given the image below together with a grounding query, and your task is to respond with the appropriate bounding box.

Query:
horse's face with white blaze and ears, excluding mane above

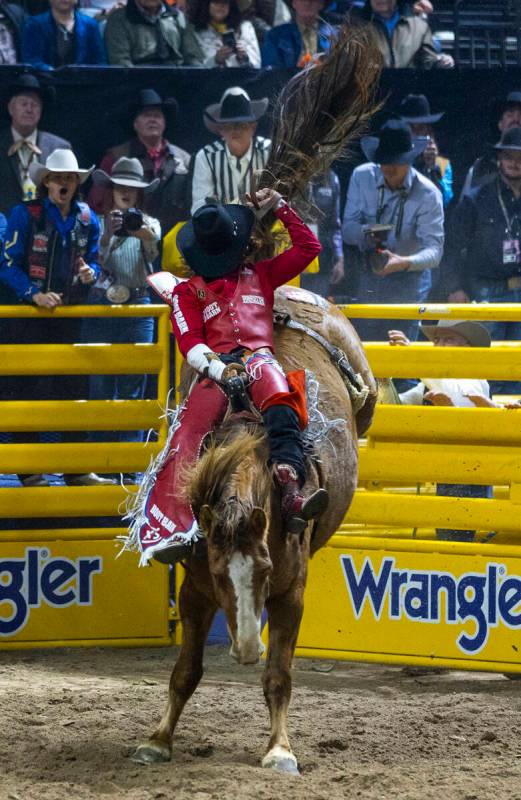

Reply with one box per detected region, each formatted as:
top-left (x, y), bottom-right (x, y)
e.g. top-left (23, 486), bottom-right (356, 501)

top-left (199, 497), bottom-right (272, 664)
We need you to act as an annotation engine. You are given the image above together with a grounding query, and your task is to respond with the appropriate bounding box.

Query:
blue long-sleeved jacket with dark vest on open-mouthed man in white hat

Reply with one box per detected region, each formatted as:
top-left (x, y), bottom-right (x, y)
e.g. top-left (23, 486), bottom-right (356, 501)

top-left (0, 198), bottom-right (101, 303)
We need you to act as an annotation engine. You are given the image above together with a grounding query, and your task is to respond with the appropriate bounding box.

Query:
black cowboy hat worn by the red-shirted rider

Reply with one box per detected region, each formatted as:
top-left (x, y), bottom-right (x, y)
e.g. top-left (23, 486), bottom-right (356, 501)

top-left (177, 203), bottom-right (255, 278)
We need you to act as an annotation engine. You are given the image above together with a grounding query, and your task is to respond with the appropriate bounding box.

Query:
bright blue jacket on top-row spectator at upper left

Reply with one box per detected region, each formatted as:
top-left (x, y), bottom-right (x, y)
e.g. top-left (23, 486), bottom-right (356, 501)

top-left (22, 11), bottom-right (107, 69)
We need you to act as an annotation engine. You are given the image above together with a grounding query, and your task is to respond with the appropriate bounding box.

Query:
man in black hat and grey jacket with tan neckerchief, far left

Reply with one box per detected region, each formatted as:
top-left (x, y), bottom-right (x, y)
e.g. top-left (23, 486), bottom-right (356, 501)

top-left (0, 73), bottom-right (71, 214)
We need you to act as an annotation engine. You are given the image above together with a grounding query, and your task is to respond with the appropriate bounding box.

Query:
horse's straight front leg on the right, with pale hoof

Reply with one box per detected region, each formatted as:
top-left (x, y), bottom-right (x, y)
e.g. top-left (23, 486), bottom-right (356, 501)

top-left (262, 586), bottom-right (304, 775)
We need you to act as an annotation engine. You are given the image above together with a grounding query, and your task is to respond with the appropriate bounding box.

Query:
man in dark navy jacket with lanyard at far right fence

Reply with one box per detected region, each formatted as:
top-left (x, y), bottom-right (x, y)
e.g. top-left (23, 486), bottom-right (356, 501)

top-left (441, 128), bottom-right (521, 394)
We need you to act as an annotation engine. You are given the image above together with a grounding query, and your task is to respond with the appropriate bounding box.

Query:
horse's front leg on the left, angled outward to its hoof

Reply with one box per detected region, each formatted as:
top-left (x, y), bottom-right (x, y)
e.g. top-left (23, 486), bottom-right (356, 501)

top-left (134, 575), bottom-right (217, 764)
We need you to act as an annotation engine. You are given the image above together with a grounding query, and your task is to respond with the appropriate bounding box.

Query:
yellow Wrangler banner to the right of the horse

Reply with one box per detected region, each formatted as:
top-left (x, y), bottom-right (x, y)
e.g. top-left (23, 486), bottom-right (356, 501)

top-left (298, 535), bottom-right (521, 671)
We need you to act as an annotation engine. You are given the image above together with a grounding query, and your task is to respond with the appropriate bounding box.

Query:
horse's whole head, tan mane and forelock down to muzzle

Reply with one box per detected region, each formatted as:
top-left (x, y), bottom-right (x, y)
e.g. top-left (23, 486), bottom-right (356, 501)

top-left (190, 429), bottom-right (272, 664)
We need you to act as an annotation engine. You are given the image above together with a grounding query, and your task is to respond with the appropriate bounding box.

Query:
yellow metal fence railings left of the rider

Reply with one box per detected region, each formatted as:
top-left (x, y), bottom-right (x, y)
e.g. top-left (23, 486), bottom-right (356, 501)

top-left (0, 305), bottom-right (170, 494)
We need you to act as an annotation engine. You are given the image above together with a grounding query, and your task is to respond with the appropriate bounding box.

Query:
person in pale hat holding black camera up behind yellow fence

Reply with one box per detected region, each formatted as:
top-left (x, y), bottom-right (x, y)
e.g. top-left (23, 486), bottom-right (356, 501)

top-left (83, 157), bottom-right (161, 483)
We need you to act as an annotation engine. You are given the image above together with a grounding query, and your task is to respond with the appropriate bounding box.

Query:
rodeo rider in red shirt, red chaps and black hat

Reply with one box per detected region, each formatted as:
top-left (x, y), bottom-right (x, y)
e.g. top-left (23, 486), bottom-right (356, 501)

top-left (134, 189), bottom-right (328, 563)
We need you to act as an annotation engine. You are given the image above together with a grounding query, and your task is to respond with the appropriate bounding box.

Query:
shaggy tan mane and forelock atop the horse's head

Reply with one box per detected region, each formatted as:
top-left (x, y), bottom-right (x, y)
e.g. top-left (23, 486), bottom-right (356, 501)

top-left (187, 420), bottom-right (272, 543)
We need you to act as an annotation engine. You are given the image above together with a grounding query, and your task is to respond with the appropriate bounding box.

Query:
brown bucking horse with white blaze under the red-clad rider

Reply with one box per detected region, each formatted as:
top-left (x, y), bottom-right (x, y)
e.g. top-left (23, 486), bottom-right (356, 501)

top-left (134, 287), bottom-right (376, 774)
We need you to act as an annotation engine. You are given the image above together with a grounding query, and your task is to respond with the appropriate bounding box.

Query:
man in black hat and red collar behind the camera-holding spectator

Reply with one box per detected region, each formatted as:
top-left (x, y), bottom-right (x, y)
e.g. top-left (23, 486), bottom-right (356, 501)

top-left (89, 89), bottom-right (190, 238)
